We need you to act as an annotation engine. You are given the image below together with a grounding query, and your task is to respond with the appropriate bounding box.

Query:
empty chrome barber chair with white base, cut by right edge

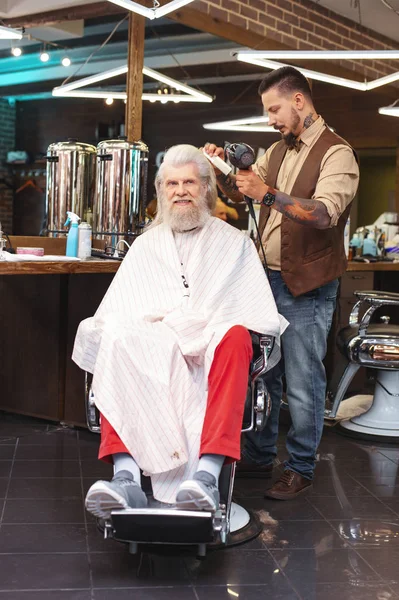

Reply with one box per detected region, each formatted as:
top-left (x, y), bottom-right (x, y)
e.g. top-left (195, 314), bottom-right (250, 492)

top-left (325, 291), bottom-right (399, 442)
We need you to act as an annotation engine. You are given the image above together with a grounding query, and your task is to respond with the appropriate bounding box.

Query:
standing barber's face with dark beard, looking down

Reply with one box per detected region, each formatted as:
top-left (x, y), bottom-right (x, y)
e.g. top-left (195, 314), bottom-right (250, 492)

top-left (262, 88), bottom-right (302, 145)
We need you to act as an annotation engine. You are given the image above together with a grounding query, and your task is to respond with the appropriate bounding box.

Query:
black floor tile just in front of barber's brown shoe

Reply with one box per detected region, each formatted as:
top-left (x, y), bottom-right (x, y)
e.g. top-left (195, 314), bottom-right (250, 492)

top-left (240, 495), bottom-right (324, 521)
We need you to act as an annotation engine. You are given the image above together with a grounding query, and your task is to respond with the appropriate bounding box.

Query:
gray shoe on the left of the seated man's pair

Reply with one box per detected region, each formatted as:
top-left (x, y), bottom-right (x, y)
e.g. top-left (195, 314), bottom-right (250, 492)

top-left (85, 471), bottom-right (147, 519)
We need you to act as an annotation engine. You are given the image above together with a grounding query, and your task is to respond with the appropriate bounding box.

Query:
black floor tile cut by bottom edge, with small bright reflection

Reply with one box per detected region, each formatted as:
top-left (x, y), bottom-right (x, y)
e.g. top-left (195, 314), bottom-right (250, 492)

top-left (195, 578), bottom-right (299, 600)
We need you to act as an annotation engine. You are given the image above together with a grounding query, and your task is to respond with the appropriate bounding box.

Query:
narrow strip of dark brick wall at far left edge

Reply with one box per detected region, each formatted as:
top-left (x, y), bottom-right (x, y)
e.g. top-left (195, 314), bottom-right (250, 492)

top-left (0, 98), bottom-right (16, 233)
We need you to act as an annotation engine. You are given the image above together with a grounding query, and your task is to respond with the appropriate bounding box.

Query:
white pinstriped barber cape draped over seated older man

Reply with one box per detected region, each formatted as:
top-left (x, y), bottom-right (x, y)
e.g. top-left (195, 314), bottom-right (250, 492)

top-left (72, 217), bottom-right (287, 503)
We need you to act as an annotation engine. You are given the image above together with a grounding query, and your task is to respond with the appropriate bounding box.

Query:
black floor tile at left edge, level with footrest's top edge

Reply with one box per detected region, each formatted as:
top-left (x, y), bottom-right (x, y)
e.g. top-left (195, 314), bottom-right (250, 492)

top-left (3, 498), bottom-right (84, 523)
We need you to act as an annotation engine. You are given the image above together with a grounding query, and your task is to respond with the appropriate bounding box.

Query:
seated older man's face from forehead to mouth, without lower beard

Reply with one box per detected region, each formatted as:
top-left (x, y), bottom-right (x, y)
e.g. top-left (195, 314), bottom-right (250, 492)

top-left (164, 164), bottom-right (201, 214)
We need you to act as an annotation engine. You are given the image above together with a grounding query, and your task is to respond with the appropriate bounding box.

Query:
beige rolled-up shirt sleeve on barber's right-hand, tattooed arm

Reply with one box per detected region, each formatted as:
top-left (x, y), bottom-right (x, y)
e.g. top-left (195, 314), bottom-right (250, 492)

top-left (312, 145), bottom-right (359, 227)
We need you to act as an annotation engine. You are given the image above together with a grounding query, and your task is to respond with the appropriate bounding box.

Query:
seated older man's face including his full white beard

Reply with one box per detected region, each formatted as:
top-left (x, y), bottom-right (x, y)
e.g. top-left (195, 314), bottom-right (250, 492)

top-left (163, 163), bottom-right (208, 231)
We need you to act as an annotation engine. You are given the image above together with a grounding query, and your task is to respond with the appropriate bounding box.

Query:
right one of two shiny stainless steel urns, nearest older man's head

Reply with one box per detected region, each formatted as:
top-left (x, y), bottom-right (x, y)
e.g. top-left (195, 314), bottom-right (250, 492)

top-left (93, 137), bottom-right (148, 246)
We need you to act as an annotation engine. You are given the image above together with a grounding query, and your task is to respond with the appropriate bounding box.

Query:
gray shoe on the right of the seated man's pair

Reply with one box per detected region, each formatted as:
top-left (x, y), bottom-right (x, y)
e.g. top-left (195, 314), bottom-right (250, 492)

top-left (176, 471), bottom-right (220, 512)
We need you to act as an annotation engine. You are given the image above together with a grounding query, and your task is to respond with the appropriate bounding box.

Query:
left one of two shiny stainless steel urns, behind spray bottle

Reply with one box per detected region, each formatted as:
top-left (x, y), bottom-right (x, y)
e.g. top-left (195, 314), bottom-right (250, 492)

top-left (45, 139), bottom-right (96, 237)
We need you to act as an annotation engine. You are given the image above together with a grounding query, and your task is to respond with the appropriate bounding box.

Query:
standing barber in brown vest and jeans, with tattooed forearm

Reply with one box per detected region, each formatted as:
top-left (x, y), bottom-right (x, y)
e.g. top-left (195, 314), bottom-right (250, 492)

top-left (205, 67), bottom-right (359, 500)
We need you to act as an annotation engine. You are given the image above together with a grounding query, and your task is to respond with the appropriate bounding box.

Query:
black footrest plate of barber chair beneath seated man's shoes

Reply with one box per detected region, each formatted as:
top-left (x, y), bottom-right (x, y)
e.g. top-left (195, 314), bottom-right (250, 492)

top-left (111, 508), bottom-right (215, 544)
